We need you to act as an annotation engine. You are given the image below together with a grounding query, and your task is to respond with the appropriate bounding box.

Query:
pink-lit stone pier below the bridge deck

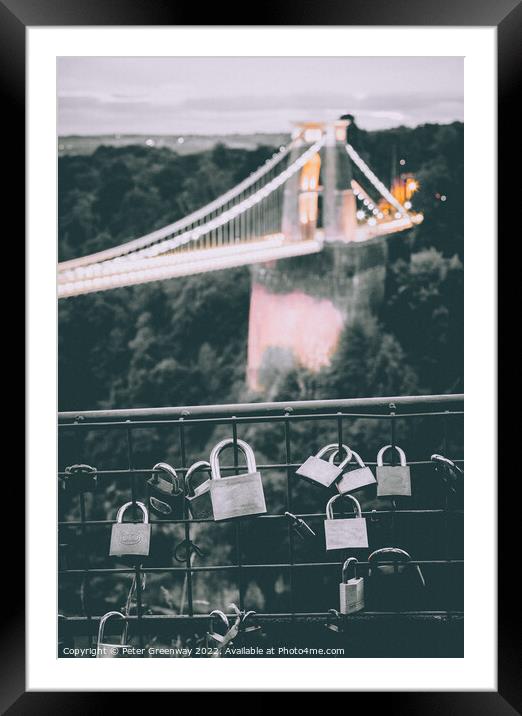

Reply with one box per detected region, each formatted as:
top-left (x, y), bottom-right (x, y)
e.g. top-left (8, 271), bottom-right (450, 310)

top-left (247, 238), bottom-right (388, 399)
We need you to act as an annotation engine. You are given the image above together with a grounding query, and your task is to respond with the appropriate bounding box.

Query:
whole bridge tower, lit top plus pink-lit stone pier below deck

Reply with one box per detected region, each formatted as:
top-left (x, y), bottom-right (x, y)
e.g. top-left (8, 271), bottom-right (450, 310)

top-left (247, 119), bottom-right (387, 400)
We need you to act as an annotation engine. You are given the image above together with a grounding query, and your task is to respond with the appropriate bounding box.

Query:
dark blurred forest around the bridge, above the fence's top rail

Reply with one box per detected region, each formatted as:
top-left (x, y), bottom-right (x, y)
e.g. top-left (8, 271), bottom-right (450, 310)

top-left (59, 122), bottom-right (463, 410)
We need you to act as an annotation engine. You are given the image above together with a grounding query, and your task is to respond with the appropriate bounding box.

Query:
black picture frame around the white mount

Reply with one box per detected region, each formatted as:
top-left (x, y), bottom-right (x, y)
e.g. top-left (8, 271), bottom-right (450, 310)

top-left (10, 0), bottom-right (512, 704)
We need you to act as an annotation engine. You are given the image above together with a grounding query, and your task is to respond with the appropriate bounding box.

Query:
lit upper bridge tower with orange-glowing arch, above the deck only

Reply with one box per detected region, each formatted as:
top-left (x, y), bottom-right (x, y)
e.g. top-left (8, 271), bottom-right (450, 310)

top-left (282, 119), bottom-right (356, 242)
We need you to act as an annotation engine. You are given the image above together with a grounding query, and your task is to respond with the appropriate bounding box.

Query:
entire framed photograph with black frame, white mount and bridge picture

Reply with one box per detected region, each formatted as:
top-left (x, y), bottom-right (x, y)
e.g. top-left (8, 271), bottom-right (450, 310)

top-left (12, 0), bottom-right (521, 714)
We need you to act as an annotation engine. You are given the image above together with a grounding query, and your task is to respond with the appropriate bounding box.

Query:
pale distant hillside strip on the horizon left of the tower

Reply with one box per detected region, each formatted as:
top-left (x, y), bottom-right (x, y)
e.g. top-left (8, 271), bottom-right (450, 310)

top-left (58, 134), bottom-right (290, 156)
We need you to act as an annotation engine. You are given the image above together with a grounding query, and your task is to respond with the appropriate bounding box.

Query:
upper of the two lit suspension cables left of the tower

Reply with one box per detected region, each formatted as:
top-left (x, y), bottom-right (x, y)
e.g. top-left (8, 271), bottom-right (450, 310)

top-left (59, 140), bottom-right (295, 271)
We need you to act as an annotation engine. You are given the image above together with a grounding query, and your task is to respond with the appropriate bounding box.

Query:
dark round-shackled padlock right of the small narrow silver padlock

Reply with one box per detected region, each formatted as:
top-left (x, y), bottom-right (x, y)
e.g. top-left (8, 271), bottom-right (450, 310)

top-left (366, 547), bottom-right (426, 611)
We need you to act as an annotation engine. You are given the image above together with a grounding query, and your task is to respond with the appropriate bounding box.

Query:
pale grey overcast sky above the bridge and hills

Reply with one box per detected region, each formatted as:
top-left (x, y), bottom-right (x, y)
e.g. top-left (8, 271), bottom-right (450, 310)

top-left (57, 57), bottom-right (464, 135)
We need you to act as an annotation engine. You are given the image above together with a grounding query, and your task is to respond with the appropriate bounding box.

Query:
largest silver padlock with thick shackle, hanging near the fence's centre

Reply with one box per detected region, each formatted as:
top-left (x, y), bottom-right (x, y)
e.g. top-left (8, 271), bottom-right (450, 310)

top-left (210, 438), bottom-right (266, 521)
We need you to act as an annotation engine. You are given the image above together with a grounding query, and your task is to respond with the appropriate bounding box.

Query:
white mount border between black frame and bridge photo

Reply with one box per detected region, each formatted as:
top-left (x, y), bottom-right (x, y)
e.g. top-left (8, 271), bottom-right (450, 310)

top-left (27, 27), bottom-right (496, 691)
